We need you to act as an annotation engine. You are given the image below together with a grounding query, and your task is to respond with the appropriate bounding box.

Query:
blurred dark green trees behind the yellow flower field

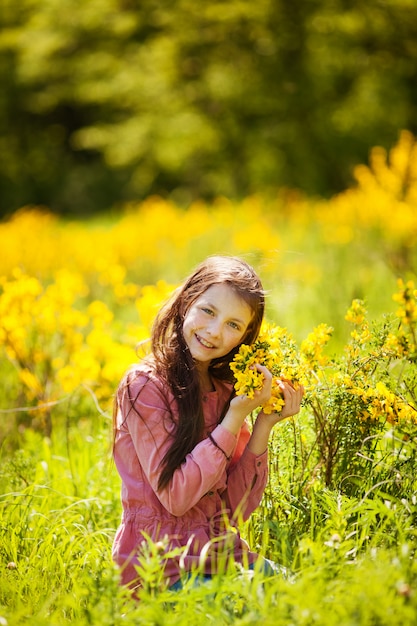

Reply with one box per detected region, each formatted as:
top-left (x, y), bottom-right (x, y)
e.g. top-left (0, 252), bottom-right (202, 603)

top-left (0, 0), bottom-right (417, 215)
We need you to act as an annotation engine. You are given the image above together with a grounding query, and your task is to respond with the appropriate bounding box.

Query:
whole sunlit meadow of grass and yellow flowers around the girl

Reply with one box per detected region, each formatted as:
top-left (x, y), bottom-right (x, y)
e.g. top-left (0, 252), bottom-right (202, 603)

top-left (0, 131), bottom-right (417, 626)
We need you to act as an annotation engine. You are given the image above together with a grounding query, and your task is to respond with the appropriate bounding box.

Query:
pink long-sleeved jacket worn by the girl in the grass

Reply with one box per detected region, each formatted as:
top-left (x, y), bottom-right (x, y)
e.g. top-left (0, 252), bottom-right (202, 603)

top-left (113, 364), bottom-right (268, 586)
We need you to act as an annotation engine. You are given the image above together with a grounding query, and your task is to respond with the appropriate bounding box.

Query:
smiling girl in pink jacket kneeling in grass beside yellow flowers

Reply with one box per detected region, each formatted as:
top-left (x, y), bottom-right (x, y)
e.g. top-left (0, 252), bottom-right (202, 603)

top-left (113, 256), bottom-right (303, 588)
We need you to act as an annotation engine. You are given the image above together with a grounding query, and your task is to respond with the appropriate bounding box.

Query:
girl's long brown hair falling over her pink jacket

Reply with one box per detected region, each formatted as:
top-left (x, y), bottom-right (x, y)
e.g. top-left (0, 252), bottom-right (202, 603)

top-left (117, 256), bottom-right (265, 489)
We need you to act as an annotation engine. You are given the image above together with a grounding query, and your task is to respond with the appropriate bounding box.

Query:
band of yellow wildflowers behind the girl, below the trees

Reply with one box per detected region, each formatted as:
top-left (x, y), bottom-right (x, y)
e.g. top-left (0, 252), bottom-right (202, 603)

top-left (0, 132), bottom-right (417, 448)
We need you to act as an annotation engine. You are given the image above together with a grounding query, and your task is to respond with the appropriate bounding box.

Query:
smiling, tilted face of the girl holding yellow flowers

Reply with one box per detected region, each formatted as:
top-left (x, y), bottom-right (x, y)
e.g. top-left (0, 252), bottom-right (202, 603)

top-left (183, 284), bottom-right (252, 368)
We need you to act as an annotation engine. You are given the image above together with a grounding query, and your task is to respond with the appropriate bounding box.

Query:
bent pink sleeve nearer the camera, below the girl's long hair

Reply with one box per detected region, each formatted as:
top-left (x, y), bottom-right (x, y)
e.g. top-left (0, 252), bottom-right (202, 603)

top-left (122, 376), bottom-right (236, 517)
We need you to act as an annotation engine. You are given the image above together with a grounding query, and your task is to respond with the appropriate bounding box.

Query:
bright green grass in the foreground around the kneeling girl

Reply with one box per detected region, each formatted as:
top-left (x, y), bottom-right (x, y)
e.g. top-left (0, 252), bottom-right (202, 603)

top-left (0, 420), bottom-right (417, 626)
